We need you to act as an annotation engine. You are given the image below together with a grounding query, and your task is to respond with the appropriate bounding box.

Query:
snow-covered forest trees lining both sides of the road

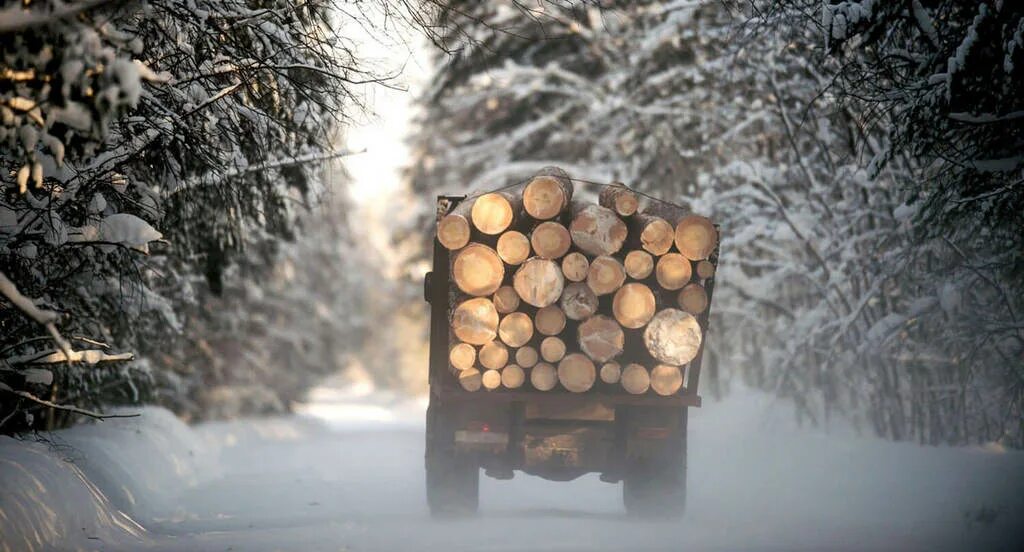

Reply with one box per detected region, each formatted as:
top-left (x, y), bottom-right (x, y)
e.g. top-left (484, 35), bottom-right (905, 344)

top-left (0, 0), bottom-right (1024, 449)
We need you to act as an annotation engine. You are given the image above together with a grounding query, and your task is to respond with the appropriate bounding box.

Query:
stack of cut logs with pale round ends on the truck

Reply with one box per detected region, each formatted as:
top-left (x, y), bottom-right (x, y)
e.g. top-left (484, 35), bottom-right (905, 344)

top-left (437, 167), bottom-right (719, 395)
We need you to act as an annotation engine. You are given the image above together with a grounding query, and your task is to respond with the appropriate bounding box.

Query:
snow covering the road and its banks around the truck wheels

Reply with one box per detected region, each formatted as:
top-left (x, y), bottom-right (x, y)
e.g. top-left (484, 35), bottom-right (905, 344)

top-left (0, 383), bottom-right (1024, 552)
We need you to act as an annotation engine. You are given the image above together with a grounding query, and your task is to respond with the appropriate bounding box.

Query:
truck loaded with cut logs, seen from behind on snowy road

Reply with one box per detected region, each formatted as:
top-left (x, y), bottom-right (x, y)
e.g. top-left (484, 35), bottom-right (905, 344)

top-left (424, 167), bottom-right (719, 517)
